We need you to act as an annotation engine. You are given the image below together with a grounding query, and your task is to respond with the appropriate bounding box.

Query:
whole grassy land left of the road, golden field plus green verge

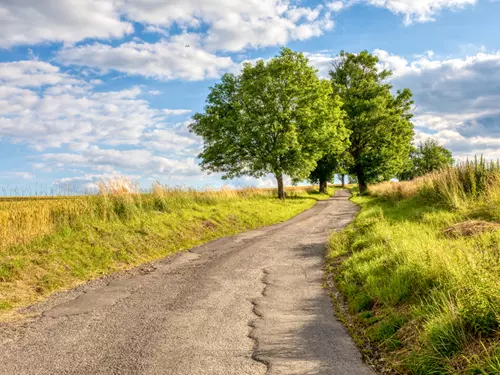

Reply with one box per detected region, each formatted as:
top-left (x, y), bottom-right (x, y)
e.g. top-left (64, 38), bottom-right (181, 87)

top-left (0, 186), bottom-right (332, 318)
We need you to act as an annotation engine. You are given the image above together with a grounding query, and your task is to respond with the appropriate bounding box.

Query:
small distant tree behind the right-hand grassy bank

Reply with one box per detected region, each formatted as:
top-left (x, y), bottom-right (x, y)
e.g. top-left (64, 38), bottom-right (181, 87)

top-left (399, 139), bottom-right (454, 180)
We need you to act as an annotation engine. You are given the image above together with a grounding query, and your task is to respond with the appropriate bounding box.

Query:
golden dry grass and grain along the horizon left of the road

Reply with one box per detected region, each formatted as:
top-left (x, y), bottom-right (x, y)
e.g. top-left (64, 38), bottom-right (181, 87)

top-left (0, 177), bottom-right (318, 251)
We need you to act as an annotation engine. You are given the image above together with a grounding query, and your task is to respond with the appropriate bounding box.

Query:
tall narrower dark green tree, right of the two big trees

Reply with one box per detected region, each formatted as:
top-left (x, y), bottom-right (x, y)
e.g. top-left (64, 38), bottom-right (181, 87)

top-left (330, 51), bottom-right (413, 193)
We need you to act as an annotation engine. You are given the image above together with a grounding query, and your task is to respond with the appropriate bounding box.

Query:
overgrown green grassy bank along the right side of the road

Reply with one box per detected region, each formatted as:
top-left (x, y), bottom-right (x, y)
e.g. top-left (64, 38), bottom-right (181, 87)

top-left (328, 161), bottom-right (500, 375)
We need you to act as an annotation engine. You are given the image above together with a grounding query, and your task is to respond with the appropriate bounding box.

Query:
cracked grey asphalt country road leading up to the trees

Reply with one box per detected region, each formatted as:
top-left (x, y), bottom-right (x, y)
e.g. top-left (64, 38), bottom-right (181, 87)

top-left (0, 191), bottom-right (374, 375)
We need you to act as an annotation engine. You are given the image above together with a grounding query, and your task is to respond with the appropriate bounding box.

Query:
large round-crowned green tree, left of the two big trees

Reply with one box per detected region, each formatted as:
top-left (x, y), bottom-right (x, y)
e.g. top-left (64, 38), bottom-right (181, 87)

top-left (190, 48), bottom-right (347, 199)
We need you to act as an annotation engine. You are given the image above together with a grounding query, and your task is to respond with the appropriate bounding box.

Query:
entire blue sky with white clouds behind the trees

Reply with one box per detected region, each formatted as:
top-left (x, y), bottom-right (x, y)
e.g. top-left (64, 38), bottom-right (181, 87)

top-left (0, 0), bottom-right (500, 194)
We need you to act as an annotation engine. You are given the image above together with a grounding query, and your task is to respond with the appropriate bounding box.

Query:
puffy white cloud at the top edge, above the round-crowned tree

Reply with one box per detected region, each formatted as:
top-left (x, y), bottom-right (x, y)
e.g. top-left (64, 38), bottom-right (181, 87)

top-left (121, 0), bottom-right (333, 51)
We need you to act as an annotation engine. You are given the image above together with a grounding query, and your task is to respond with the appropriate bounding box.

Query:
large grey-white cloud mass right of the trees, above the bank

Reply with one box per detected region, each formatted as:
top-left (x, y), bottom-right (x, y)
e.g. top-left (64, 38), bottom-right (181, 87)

top-left (377, 51), bottom-right (500, 158)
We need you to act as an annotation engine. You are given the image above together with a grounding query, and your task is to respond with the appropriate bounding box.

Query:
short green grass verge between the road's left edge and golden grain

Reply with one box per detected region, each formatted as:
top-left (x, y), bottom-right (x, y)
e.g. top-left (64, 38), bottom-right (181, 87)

top-left (0, 190), bottom-right (333, 320)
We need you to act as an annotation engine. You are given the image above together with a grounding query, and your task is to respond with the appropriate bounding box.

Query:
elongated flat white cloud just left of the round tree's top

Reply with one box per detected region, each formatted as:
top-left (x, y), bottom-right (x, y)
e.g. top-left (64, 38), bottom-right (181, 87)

top-left (58, 34), bottom-right (234, 80)
